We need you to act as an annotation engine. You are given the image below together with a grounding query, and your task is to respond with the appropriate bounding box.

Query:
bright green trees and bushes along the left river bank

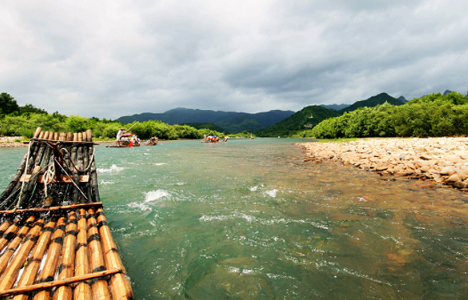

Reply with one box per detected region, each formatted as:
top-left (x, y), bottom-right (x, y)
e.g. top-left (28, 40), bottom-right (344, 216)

top-left (0, 93), bottom-right (224, 140)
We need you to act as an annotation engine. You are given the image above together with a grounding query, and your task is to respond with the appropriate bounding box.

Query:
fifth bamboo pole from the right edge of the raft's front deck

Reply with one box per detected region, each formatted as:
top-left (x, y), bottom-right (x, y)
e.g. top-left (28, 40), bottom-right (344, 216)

top-left (33, 217), bottom-right (65, 300)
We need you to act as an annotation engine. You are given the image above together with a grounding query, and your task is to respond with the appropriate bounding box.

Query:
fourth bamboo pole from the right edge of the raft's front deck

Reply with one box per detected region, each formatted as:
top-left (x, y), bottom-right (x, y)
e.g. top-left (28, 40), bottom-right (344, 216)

top-left (54, 211), bottom-right (77, 300)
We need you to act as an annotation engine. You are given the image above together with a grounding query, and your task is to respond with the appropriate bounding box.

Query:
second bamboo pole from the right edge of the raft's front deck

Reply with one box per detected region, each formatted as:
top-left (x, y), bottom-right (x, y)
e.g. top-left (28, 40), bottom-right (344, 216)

top-left (88, 208), bottom-right (111, 300)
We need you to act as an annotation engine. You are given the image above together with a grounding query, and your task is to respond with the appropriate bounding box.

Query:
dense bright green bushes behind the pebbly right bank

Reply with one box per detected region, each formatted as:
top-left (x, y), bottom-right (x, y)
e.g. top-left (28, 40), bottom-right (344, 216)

top-left (306, 92), bottom-right (468, 138)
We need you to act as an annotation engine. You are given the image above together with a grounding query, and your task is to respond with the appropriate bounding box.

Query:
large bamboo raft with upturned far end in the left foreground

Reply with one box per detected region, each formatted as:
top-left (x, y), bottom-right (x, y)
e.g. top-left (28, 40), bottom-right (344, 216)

top-left (0, 128), bottom-right (134, 300)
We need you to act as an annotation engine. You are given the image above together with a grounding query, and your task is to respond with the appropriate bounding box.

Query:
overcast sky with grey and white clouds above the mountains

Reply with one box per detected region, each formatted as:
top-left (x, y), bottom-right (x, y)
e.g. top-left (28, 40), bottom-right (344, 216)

top-left (0, 0), bottom-right (468, 119)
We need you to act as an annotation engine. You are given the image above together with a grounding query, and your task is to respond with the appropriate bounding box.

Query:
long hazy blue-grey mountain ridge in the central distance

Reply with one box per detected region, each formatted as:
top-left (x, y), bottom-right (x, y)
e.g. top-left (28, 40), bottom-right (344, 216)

top-left (117, 108), bottom-right (294, 133)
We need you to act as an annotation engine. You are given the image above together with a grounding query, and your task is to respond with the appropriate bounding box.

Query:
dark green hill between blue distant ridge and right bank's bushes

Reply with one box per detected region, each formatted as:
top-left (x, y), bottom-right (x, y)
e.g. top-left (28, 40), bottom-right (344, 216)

top-left (256, 105), bottom-right (339, 137)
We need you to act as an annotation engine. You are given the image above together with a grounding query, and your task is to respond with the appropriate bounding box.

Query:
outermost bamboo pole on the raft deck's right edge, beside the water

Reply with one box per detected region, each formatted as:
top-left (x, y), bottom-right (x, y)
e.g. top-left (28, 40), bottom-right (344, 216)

top-left (97, 208), bottom-right (135, 299)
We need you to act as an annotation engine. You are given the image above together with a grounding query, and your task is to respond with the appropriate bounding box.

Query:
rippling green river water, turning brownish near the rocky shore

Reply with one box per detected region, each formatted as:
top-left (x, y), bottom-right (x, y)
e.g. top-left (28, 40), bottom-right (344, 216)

top-left (0, 139), bottom-right (468, 299)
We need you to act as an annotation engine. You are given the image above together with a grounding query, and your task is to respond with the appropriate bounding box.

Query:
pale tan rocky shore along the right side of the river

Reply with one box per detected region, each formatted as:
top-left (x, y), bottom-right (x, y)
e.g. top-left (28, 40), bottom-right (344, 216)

top-left (300, 138), bottom-right (468, 191)
